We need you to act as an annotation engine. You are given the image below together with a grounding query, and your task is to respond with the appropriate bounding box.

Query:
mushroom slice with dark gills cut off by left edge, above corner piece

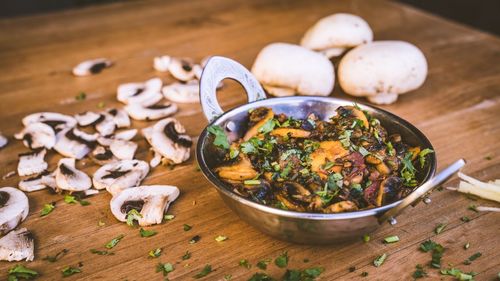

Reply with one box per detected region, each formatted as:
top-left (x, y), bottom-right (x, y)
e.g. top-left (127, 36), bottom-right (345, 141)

top-left (0, 187), bottom-right (29, 236)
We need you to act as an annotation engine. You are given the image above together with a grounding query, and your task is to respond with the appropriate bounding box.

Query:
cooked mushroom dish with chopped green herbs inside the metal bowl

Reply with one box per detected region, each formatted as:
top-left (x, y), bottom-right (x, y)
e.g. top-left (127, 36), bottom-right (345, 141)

top-left (208, 105), bottom-right (433, 213)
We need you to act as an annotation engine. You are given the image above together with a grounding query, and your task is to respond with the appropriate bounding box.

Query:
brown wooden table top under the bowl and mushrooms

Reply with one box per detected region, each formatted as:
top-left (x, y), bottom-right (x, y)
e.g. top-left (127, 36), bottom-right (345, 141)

top-left (0, 0), bottom-right (500, 280)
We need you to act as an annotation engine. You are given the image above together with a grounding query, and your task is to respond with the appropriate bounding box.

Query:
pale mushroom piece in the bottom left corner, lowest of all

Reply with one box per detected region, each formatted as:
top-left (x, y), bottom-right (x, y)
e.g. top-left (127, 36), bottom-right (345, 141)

top-left (0, 227), bottom-right (35, 262)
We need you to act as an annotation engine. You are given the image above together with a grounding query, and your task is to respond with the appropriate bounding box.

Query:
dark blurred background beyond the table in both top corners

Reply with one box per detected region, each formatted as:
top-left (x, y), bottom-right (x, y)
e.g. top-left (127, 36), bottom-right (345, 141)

top-left (0, 0), bottom-right (500, 35)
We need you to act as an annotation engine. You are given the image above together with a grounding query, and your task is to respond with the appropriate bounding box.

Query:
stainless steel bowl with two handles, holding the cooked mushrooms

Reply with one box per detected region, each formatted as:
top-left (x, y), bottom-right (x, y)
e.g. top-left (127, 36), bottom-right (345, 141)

top-left (196, 57), bottom-right (460, 244)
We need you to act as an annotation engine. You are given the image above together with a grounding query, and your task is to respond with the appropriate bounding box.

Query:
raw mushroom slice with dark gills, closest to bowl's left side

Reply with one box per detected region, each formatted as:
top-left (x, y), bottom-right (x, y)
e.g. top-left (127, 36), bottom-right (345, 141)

top-left (151, 118), bottom-right (193, 164)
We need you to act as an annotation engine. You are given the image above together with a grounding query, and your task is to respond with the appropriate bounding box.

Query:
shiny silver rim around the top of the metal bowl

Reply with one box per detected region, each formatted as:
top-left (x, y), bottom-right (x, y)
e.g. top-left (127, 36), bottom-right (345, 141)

top-left (196, 96), bottom-right (437, 220)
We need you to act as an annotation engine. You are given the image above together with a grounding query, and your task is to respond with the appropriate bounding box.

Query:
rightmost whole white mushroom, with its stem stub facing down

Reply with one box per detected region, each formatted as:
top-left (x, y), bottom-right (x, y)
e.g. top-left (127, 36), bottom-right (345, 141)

top-left (338, 41), bottom-right (427, 104)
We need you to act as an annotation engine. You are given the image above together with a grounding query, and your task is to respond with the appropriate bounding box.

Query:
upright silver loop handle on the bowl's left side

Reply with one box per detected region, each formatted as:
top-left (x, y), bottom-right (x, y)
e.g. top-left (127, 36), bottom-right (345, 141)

top-left (200, 56), bottom-right (266, 122)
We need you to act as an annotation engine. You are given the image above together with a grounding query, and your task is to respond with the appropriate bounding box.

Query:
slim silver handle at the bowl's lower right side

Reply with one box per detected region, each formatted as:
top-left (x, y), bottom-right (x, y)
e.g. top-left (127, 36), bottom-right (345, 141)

top-left (378, 159), bottom-right (465, 224)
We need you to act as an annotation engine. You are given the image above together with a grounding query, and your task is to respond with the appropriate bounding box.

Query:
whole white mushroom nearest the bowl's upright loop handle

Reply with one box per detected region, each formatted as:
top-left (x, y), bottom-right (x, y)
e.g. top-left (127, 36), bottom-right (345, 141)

top-left (252, 43), bottom-right (335, 96)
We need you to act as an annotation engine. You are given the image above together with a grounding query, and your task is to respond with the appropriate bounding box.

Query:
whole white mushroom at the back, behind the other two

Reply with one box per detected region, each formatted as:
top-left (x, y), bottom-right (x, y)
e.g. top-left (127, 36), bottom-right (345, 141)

top-left (300, 13), bottom-right (373, 54)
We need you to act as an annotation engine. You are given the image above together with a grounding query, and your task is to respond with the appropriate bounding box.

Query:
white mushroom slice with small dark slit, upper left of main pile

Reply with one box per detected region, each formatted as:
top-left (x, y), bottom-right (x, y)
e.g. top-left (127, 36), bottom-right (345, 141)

top-left (117, 78), bottom-right (163, 106)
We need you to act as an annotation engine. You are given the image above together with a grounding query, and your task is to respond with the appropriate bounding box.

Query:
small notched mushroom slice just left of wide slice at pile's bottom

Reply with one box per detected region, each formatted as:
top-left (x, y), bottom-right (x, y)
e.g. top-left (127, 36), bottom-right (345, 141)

top-left (56, 158), bottom-right (92, 191)
